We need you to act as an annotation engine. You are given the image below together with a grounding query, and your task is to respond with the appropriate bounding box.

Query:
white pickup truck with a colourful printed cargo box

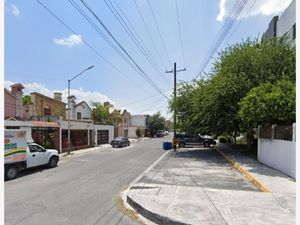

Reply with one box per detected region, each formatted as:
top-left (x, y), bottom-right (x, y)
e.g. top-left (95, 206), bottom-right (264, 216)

top-left (4, 129), bottom-right (59, 180)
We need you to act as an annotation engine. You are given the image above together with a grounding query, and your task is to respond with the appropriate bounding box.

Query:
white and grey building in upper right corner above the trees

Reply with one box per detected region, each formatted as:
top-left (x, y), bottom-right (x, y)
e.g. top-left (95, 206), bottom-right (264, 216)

top-left (262, 0), bottom-right (296, 47)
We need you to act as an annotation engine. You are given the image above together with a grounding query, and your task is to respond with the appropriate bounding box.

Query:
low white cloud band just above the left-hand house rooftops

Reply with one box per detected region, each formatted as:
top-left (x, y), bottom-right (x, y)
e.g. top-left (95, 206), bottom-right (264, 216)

top-left (4, 80), bottom-right (115, 107)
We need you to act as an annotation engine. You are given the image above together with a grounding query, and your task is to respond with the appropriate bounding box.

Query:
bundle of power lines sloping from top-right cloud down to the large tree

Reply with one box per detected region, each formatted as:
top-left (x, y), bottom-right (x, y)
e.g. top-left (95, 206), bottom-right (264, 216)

top-left (194, 0), bottom-right (248, 79)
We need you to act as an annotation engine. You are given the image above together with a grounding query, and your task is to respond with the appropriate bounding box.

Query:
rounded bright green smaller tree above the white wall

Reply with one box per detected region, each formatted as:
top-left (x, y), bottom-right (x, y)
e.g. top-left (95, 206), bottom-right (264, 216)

top-left (239, 80), bottom-right (296, 128)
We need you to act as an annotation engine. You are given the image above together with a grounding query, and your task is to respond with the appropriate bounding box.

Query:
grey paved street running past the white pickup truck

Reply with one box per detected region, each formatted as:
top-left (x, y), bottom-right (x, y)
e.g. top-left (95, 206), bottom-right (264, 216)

top-left (5, 138), bottom-right (168, 225)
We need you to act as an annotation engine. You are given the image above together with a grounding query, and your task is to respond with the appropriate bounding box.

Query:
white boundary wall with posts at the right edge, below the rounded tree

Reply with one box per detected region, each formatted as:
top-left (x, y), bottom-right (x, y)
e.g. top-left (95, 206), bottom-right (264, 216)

top-left (257, 124), bottom-right (296, 178)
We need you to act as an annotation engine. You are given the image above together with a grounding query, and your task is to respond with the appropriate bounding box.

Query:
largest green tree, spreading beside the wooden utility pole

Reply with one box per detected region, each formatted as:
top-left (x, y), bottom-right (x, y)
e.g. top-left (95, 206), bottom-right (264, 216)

top-left (170, 38), bottom-right (295, 142)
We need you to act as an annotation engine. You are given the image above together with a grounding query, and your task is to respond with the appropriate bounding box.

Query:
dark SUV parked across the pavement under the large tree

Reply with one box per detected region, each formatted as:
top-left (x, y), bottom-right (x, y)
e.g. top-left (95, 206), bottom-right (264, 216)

top-left (178, 134), bottom-right (216, 148)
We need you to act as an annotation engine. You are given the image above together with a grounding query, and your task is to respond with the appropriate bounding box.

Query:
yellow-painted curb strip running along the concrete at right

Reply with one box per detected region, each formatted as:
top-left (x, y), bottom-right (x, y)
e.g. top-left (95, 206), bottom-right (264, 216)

top-left (215, 147), bottom-right (272, 192)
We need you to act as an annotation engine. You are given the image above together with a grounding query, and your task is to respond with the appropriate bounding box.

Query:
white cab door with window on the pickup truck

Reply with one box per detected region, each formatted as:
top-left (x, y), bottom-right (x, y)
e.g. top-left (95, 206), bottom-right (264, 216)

top-left (27, 144), bottom-right (48, 167)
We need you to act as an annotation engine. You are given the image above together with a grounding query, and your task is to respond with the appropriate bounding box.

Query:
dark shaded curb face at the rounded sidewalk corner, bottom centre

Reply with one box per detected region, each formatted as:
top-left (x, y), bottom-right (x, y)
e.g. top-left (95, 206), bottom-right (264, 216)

top-left (127, 195), bottom-right (191, 225)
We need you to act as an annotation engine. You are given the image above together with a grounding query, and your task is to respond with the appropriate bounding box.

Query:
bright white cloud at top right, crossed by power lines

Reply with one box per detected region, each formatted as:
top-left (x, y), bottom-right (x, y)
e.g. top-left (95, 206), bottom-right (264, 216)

top-left (217, 0), bottom-right (292, 21)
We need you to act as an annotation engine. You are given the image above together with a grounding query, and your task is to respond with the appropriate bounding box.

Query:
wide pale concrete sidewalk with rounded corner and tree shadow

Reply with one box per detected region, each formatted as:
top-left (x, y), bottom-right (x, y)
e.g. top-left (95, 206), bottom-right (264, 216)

top-left (127, 145), bottom-right (296, 225)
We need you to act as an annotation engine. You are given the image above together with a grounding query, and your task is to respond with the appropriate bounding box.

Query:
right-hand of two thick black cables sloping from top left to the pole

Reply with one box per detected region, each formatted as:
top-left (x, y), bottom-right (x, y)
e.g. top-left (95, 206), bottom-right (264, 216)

top-left (81, 0), bottom-right (169, 99)
